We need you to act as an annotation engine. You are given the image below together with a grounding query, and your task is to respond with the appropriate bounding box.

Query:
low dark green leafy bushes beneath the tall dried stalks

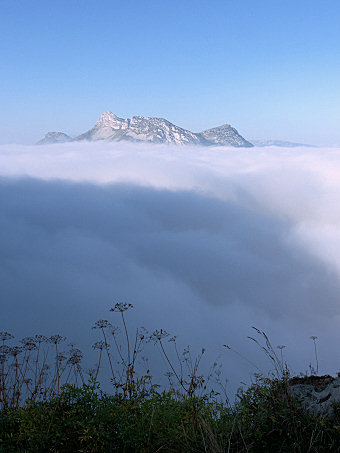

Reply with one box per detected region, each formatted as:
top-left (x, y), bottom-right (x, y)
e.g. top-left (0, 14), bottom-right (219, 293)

top-left (0, 381), bottom-right (340, 453)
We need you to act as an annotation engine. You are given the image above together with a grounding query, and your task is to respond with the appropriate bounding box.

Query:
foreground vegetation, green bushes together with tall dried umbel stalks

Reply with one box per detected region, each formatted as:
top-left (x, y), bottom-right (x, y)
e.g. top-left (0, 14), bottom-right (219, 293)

top-left (0, 304), bottom-right (340, 453)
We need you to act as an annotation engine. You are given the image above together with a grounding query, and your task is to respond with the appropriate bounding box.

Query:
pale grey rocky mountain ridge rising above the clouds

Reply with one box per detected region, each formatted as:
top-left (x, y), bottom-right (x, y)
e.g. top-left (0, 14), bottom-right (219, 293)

top-left (38, 111), bottom-right (253, 147)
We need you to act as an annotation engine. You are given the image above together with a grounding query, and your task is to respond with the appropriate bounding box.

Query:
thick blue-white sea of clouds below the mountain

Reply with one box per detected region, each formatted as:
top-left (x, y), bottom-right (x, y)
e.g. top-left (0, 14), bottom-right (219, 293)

top-left (0, 143), bottom-right (340, 396)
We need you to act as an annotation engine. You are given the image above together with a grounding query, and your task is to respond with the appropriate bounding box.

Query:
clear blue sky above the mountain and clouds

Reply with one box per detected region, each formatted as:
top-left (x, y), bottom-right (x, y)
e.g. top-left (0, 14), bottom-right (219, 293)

top-left (0, 0), bottom-right (340, 145)
